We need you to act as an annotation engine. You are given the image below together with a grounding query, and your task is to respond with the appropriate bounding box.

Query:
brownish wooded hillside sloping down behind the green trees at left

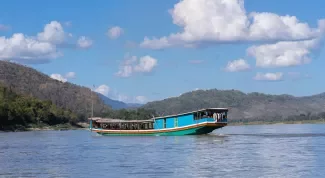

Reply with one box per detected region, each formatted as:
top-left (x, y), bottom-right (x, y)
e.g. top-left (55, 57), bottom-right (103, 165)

top-left (0, 60), bottom-right (110, 118)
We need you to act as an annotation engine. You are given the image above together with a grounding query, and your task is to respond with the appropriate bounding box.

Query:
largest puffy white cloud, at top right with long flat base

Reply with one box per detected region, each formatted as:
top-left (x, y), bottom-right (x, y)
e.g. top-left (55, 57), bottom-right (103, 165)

top-left (140, 0), bottom-right (325, 49)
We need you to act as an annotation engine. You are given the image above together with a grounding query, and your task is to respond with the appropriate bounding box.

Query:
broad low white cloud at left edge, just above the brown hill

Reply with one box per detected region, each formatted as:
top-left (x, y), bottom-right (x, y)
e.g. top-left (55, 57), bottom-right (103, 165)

top-left (0, 33), bottom-right (62, 63)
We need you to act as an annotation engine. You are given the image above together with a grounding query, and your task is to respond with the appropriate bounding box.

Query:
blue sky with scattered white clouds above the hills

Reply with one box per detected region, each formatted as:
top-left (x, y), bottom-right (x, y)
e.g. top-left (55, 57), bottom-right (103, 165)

top-left (0, 0), bottom-right (325, 103)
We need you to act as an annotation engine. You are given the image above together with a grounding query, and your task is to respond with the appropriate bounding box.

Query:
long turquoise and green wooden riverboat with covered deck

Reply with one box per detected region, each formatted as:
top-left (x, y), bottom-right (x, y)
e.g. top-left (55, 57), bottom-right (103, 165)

top-left (89, 108), bottom-right (228, 136)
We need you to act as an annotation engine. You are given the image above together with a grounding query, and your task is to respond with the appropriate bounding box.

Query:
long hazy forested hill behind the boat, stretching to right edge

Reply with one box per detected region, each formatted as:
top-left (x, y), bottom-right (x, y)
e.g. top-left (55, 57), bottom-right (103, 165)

top-left (143, 89), bottom-right (325, 121)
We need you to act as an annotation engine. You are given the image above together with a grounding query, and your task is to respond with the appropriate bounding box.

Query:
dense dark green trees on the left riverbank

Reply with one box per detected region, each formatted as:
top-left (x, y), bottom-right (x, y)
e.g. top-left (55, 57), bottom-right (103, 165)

top-left (0, 86), bottom-right (78, 131)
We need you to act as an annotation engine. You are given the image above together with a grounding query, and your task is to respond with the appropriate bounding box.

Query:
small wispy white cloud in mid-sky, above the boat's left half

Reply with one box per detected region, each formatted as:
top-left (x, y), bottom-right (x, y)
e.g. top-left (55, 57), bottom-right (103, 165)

top-left (116, 55), bottom-right (158, 77)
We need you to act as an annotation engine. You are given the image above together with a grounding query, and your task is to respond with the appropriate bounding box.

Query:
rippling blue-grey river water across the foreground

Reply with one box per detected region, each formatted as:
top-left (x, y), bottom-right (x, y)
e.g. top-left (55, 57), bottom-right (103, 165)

top-left (0, 124), bottom-right (325, 178)
